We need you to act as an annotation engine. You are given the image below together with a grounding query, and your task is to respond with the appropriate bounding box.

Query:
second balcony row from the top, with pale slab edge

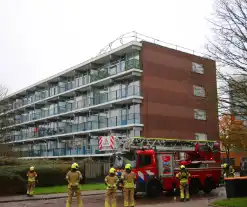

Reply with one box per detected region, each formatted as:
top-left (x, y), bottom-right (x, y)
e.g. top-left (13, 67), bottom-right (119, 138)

top-left (7, 85), bottom-right (141, 128)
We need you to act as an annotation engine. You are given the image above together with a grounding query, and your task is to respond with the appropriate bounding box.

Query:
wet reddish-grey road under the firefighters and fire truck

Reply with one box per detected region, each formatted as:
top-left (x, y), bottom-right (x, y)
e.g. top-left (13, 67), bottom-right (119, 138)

top-left (0, 188), bottom-right (224, 207)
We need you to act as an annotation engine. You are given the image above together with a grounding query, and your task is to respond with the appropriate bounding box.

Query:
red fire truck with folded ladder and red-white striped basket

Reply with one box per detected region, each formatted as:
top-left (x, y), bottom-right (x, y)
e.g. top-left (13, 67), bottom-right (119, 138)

top-left (100, 136), bottom-right (221, 197)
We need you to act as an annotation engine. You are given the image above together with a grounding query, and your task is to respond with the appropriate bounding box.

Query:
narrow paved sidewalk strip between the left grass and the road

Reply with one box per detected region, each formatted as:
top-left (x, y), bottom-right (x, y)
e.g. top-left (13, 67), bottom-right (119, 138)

top-left (0, 190), bottom-right (106, 203)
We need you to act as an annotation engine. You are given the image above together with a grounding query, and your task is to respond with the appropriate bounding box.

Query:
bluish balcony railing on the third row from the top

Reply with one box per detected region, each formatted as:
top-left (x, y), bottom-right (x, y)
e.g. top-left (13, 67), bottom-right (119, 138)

top-left (5, 113), bottom-right (141, 142)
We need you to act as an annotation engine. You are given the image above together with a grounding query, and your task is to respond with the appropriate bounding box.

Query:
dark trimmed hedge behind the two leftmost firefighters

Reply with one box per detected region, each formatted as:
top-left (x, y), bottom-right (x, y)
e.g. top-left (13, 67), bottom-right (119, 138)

top-left (0, 164), bottom-right (86, 195)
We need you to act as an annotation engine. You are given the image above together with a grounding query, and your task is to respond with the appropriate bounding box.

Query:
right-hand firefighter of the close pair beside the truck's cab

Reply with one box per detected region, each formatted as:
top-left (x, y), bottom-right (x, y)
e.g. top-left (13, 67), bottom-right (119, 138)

top-left (121, 164), bottom-right (136, 207)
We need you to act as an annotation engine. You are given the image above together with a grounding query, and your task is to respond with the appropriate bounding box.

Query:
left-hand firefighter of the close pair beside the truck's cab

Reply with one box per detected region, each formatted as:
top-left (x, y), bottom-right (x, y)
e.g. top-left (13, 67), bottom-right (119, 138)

top-left (105, 168), bottom-right (118, 207)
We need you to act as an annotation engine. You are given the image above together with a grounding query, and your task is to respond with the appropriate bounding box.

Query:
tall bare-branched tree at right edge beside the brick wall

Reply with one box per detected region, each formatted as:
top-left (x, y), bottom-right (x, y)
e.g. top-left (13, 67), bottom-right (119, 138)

top-left (207, 0), bottom-right (247, 116)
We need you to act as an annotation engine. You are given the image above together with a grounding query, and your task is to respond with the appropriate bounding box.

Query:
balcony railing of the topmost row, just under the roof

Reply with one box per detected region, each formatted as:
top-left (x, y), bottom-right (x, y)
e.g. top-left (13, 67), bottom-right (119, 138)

top-left (5, 59), bottom-right (140, 111)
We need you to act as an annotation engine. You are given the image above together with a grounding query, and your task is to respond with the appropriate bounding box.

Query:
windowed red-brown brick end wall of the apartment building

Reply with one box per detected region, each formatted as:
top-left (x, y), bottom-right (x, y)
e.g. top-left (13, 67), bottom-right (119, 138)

top-left (141, 42), bottom-right (219, 140)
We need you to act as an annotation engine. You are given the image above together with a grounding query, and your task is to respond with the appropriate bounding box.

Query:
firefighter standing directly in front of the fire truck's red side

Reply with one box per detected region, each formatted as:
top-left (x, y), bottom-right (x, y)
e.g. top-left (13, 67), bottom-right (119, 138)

top-left (176, 165), bottom-right (190, 201)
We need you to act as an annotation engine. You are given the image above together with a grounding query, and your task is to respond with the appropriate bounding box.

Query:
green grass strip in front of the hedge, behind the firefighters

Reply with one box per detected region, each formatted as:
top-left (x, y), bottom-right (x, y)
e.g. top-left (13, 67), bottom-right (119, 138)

top-left (34, 183), bottom-right (106, 195)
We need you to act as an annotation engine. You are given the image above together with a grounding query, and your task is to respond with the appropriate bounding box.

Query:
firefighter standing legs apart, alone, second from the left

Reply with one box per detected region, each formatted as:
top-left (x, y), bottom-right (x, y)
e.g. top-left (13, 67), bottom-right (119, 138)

top-left (66, 163), bottom-right (82, 207)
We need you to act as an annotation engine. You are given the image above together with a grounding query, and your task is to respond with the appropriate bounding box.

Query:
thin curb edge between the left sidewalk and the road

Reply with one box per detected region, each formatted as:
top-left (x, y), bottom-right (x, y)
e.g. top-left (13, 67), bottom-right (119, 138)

top-left (0, 192), bottom-right (114, 203)
